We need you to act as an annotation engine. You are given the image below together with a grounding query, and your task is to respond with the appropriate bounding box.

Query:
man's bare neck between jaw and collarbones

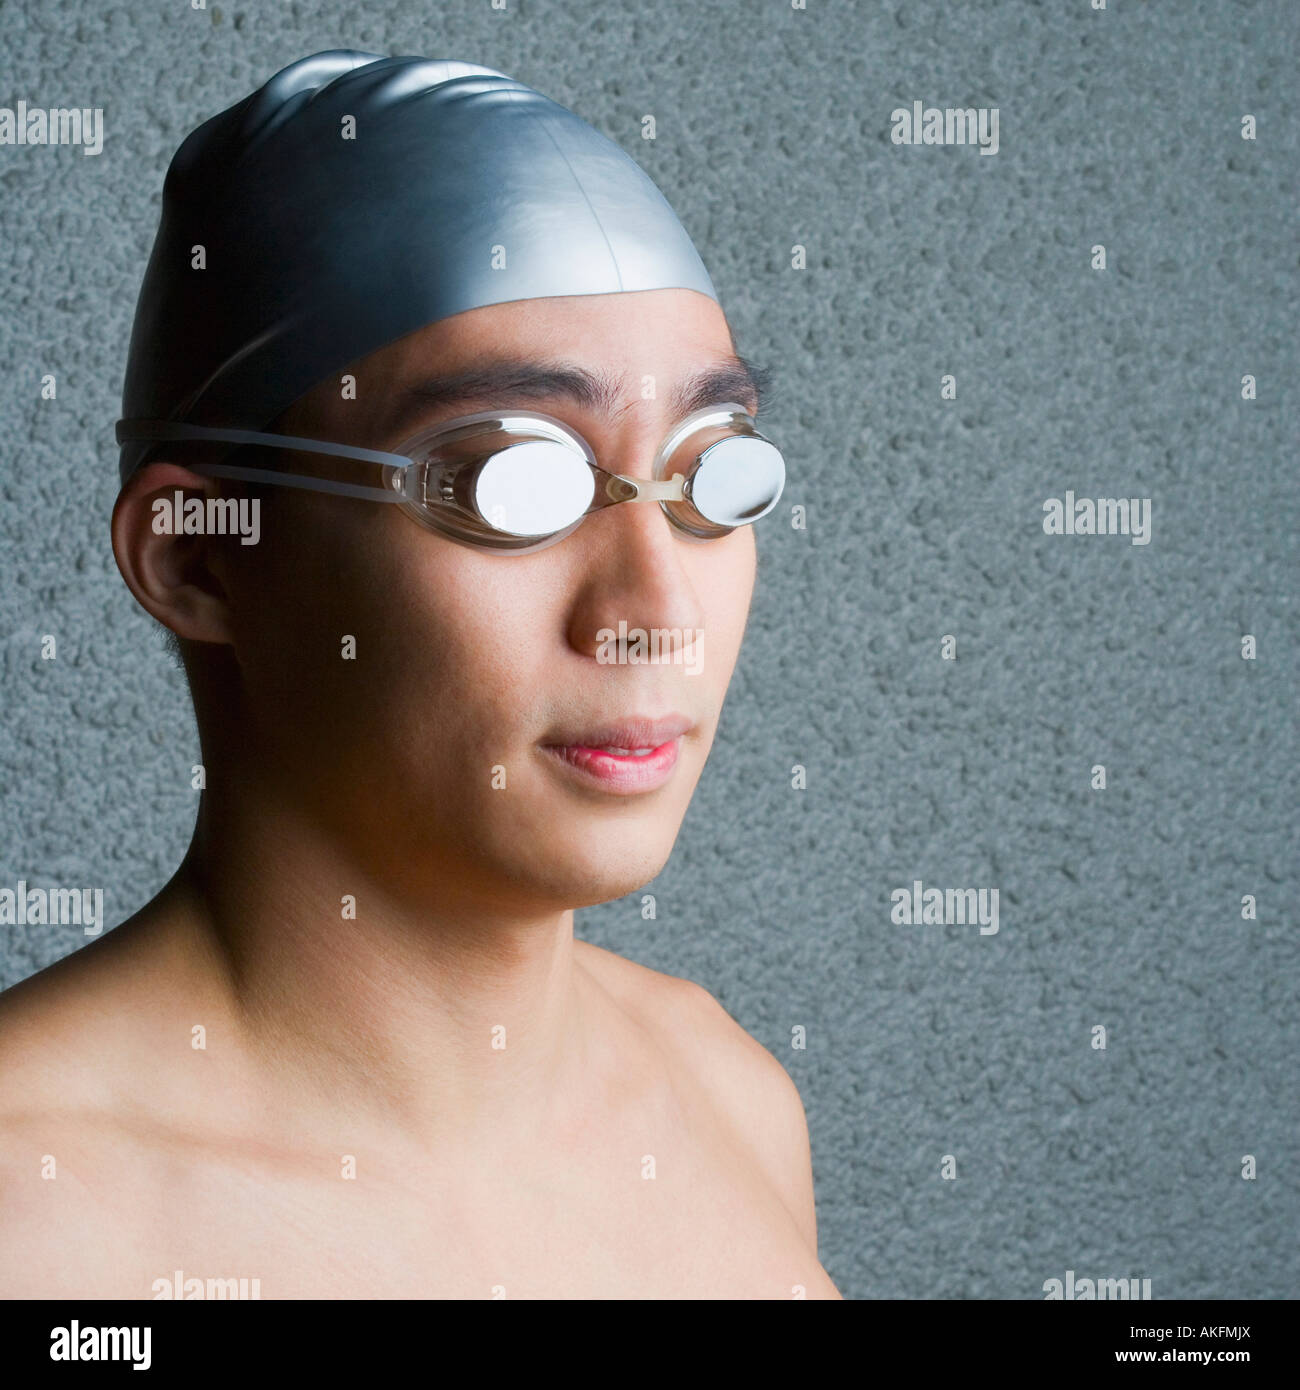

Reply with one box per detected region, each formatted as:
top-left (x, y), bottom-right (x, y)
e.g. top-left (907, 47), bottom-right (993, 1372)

top-left (168, 781), bottom-right (581, 1140)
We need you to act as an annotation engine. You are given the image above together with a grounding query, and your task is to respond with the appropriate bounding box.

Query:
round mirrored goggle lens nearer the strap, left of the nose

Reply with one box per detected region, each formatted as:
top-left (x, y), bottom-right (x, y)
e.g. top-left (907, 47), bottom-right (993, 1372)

top-left (473, 439), bottom-right (595, 535)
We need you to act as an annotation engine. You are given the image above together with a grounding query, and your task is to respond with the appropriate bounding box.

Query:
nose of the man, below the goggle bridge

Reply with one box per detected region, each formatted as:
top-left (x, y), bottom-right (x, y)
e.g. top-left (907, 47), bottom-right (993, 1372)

top-left (567, 477), bottom-right (719, 662)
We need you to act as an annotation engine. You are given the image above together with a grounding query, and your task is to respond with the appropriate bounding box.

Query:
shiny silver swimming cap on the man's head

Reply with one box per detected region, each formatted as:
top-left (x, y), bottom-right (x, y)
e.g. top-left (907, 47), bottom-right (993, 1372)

top-left (121, 49), bottom-right (717, 482)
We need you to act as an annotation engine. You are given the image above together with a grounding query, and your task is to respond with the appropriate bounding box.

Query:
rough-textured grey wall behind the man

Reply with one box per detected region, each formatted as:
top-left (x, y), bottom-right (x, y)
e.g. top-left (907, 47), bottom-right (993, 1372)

top-left (0, 0), bottom-right (1300, 1298)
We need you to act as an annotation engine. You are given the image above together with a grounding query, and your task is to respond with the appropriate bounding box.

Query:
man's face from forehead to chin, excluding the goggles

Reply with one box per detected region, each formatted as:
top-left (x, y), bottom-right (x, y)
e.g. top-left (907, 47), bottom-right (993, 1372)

top-left (212, 289), bottom-right (755, 909)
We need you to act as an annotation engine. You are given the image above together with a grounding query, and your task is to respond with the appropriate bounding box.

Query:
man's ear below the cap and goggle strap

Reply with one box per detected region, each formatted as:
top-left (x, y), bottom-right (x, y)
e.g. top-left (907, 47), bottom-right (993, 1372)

top-left (113, 463), bottom-right (234, 642)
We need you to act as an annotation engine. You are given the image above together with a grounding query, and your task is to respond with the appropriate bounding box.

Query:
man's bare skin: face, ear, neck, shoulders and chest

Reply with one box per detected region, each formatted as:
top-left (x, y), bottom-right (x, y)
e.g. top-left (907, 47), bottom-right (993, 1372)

top-left (0, 291), bottom-right (838, 1298)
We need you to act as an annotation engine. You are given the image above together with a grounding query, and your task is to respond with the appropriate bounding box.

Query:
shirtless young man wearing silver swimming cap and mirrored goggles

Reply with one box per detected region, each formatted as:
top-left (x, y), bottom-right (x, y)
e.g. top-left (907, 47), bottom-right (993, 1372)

top-left (0, 53), bottom-right (838, 1298)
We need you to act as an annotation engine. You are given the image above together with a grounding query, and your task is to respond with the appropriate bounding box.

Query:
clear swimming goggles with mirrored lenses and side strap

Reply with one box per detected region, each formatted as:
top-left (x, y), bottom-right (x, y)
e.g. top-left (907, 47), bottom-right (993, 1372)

top-left (117, 402), bottom-right (786, 553)
